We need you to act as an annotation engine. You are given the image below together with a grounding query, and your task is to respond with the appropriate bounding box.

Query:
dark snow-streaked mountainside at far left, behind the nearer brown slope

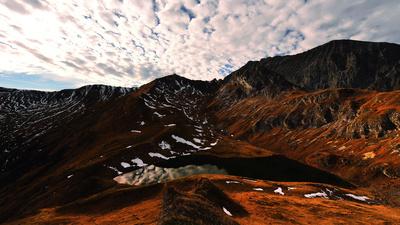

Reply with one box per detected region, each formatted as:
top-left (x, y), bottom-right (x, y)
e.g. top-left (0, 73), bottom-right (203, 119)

top-left (0, 85), bottom-right (134, 173)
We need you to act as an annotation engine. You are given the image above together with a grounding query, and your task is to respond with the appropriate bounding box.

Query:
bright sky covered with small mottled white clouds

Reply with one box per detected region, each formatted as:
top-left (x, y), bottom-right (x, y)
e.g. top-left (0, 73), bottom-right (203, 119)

top-left (0, 0), bottom-right (400, 91)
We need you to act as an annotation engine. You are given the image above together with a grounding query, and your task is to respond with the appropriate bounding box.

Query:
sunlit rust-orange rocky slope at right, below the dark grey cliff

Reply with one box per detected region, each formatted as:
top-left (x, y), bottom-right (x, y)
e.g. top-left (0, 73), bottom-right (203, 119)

top-left (213, 86), bottom-right (400, 188)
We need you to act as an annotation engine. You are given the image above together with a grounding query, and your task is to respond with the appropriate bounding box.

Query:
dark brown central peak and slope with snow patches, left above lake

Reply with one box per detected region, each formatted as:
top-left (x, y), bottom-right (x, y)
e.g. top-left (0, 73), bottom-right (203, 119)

top-left (0, 75), bottom-right (247, 220)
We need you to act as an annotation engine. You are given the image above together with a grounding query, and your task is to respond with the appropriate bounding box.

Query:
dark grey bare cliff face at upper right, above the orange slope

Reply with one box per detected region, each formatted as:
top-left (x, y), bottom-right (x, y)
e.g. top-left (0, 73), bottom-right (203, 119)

top-left (257, 40), bottom-right (400, 91)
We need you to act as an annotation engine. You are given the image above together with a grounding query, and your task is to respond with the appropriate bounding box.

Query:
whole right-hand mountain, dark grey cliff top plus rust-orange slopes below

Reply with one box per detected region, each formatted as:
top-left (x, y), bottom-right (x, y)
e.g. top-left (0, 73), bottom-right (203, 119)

top-left (209, 41), bottom-right (400, 204)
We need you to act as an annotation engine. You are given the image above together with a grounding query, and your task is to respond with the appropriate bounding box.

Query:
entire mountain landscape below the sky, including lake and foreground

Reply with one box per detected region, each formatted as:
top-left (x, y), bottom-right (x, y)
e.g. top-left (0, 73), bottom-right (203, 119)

top-left (0, 40), bottom-right (400, 224)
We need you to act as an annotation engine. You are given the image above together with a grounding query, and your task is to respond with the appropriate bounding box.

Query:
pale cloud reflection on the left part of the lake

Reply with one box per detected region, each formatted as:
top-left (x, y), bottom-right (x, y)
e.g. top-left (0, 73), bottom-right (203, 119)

top-left (114, 164), bottom-right (228, 185)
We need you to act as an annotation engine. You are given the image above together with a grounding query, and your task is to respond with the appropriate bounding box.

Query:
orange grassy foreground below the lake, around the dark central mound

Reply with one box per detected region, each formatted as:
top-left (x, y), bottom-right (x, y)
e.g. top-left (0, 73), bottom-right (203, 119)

top-left (6, 175), bottom-right (400, 224)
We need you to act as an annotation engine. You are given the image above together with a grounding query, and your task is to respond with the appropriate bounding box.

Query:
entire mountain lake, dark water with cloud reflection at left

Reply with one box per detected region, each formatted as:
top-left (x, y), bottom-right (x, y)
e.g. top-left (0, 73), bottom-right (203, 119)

top-left (114, 155), bottom-right (354, 188)
